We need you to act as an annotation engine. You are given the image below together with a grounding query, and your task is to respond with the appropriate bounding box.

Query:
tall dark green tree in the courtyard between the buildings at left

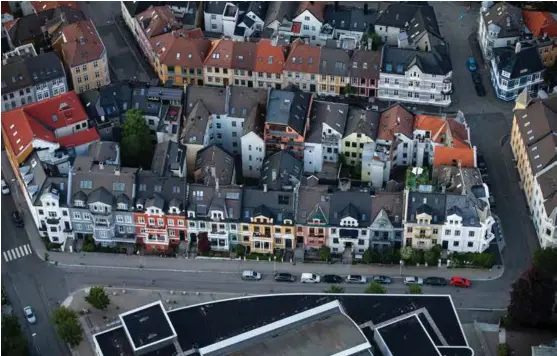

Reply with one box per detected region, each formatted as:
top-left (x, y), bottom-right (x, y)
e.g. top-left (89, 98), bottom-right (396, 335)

top-left (121, 109), bottom-right (153, 169)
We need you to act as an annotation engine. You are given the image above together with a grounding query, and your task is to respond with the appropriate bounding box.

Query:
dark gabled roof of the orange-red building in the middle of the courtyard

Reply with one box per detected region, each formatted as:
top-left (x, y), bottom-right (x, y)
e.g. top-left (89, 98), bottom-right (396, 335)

top-left (266, 87), bottom-right (313, 135)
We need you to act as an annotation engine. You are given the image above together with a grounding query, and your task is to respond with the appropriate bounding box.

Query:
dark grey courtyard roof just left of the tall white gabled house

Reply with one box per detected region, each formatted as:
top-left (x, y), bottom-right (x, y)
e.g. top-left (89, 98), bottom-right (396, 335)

top-left (194, 145), bottom-right (234, 185)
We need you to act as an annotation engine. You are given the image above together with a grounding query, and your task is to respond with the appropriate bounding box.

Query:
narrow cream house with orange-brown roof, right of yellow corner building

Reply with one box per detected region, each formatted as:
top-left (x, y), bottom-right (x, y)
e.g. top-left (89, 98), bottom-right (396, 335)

top-left (203, 40), bottom-right (234, 87)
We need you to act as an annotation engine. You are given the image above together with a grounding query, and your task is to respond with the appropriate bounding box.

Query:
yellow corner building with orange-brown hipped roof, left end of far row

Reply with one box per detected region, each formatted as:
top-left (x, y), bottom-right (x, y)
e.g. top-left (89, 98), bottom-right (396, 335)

top-left (149, 30), bottom-right (211, 86)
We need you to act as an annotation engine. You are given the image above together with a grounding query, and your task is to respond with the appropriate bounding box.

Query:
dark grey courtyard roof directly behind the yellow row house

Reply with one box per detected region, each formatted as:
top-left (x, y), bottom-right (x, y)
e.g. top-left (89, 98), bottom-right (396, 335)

top-left (261, 151), bottom-right (304, 190)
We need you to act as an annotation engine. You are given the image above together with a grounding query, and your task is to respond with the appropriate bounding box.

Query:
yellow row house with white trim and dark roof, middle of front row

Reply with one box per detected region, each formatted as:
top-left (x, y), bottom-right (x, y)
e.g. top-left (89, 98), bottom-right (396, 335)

top-left (240, 188), bottom-right (297, 253)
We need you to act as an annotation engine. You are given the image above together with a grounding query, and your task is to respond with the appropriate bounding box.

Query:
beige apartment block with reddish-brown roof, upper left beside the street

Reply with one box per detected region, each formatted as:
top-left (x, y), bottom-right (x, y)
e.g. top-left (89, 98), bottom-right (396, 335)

top-left (61, 20), bottom-right (110, 93)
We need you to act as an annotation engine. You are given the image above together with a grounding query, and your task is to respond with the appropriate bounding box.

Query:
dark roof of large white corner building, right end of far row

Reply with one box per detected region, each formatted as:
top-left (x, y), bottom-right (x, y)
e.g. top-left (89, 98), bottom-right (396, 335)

top-left (381, 40), bottom-right (453, 75)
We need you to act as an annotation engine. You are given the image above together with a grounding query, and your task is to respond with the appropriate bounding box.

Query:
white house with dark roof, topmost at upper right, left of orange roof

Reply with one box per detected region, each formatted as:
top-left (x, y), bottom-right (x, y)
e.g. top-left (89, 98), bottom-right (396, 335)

top-left (478, 2), bottom-right (524, 60)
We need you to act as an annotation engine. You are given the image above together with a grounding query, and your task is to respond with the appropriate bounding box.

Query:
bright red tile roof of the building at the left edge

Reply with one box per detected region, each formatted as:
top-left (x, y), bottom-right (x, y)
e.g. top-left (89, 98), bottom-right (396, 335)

top-left (1, 91), bottom-right (98, 156)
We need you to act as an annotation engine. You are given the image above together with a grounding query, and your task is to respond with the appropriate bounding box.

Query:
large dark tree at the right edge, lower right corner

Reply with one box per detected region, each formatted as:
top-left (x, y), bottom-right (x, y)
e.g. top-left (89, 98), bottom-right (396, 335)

top-left (507, 267), bottom-right (555, 327)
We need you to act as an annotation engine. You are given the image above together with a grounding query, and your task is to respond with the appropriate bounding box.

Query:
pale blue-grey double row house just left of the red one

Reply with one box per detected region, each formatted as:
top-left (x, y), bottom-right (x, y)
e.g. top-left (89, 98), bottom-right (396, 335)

top-left (68, 156), bottom-right (137, 246)
